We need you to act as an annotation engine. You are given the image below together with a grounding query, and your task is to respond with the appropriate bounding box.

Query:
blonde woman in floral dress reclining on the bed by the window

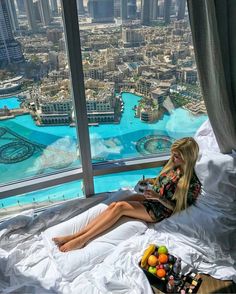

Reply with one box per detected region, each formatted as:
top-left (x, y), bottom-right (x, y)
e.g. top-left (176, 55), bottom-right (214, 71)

top-left (53, 137), bottom-right (201, 252)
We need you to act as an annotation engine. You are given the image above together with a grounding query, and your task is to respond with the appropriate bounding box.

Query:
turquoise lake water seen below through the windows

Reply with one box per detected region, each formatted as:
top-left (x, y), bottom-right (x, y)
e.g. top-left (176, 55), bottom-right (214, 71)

top-left (0, 93), bottom-right (207, 207)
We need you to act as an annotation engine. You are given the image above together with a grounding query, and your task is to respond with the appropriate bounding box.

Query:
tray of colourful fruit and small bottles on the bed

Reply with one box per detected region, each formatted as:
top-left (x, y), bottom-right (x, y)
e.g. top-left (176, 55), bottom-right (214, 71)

top-left (139, 244), bottom-right (202, 294)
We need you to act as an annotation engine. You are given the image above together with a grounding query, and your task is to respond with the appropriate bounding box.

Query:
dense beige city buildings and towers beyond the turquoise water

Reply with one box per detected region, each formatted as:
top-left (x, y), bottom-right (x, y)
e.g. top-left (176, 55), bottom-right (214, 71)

top-left (0, 0), bottom-right (206, 125)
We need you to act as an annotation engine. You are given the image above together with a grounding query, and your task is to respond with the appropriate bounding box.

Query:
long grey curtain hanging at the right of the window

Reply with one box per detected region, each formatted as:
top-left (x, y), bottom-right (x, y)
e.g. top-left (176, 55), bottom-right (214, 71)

top-left (188, 0), bottom-right (236, 153)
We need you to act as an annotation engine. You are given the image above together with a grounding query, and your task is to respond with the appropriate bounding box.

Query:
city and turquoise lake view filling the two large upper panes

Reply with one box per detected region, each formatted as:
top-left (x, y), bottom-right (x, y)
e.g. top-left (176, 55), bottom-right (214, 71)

top-left (0, 0), bottom-right (207, 207)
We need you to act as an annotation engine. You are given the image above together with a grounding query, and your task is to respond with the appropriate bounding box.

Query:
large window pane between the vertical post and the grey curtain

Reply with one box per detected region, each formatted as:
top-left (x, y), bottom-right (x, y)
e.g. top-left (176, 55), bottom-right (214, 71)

top-left (77, 0), bottom-right (207, 162)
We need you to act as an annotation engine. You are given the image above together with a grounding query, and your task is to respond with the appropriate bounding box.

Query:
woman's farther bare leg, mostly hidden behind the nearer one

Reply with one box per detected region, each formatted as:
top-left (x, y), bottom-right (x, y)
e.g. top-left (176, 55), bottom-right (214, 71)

top-left (52, 194), bottom-right (145, 246)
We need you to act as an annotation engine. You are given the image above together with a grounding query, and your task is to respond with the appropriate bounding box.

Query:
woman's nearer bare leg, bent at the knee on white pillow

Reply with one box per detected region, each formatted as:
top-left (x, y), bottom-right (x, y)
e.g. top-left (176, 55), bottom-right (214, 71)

top-left (60, 201), bottom-right (154, 252)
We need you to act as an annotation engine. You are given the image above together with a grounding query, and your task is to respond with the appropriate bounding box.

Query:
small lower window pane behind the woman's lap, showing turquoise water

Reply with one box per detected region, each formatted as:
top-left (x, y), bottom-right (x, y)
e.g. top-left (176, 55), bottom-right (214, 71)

top-left (94, 168), bottom-right (161, 193)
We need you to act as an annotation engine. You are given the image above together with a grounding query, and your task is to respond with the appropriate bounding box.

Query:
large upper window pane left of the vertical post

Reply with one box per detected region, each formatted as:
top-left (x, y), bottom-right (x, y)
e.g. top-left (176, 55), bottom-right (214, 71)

top-left (0, 0), bottom-right (81, 183)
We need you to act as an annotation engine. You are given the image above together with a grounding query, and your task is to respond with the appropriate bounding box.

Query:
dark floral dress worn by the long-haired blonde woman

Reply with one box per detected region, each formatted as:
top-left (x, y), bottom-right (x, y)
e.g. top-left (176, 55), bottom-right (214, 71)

top-left (142, 168), bottom-right (201, 222)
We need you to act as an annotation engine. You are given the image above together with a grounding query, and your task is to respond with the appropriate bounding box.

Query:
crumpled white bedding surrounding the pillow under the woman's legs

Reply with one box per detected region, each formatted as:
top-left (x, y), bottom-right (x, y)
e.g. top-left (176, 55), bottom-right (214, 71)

top-left (0, 186), bottom-right (236, 294)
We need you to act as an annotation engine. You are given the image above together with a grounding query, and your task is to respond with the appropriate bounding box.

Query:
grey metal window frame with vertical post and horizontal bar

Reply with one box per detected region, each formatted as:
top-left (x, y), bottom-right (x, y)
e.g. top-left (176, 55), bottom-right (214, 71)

top-left (0, 0), bottom-right (170, 199)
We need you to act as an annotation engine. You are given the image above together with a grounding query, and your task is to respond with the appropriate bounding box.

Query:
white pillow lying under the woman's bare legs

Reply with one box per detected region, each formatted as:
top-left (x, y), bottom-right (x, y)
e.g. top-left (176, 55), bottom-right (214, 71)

top-left (42, 203), bottom-right (147, 280)
